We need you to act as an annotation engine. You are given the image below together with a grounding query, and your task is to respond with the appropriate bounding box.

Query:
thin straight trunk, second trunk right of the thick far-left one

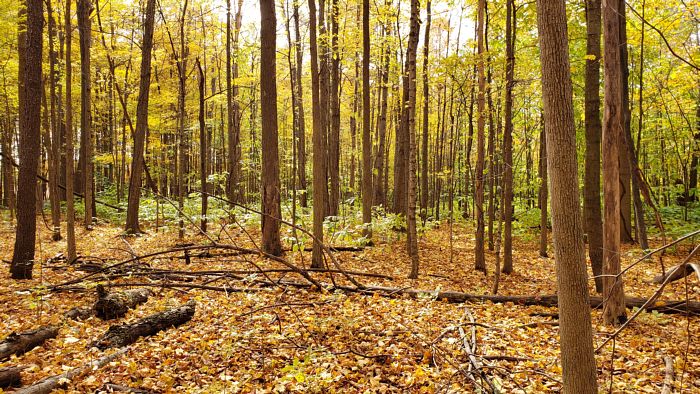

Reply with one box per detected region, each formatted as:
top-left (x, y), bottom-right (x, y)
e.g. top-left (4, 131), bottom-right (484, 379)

top-left (64, 1), bottom-right (77, 262)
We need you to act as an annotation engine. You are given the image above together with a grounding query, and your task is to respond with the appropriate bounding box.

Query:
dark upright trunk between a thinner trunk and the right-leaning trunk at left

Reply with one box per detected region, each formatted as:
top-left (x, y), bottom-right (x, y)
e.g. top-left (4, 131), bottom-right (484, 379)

top-left (78, 0), bottom-right (95, 229)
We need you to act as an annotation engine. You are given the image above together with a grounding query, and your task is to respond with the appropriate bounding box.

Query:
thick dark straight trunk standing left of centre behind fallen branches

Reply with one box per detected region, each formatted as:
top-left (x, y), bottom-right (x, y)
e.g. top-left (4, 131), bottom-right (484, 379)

top-left (260, 0), bottom-right (282, 256)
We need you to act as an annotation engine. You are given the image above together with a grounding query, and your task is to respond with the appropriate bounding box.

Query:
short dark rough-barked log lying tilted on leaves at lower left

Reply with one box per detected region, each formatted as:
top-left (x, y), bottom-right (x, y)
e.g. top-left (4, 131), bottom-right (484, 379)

top-left (91, 300), bottom-right (196, 350)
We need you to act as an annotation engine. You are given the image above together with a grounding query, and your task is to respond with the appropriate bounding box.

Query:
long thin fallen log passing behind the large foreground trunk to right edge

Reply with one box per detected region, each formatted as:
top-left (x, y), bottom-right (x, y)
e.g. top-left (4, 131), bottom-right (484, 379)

top-left (330, 282), bottom-right (700, 316)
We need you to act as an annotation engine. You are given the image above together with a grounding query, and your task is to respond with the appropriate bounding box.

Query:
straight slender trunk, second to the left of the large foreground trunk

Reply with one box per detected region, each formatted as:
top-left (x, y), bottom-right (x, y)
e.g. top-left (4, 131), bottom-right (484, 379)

top-left (503, 0), bottom-right (516, 274)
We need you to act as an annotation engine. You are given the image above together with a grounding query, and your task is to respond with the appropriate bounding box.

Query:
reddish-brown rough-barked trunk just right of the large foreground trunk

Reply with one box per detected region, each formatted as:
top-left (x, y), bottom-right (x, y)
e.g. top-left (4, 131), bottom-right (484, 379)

top-left (603, 0), bottom-right (626, 325)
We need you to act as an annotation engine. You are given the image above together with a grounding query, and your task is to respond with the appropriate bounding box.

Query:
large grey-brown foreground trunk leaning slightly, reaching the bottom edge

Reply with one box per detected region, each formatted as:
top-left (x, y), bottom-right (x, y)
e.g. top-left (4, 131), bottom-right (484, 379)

top-left (537, 0), bottom-right (598, 393)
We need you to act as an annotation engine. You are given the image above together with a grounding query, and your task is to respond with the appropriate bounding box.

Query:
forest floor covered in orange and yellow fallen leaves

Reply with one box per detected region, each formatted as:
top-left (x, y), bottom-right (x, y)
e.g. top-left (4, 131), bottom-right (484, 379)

top-left (0, 223), bottom-right (700, 393)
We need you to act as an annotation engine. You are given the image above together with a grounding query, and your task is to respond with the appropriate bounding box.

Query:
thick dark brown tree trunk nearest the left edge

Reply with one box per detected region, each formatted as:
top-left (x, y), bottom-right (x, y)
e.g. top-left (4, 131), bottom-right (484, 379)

top-left (10, 0), bottom-right (44, 279)
